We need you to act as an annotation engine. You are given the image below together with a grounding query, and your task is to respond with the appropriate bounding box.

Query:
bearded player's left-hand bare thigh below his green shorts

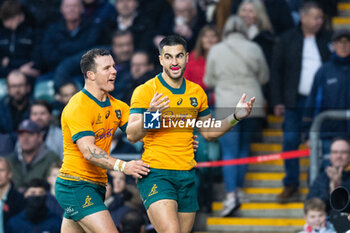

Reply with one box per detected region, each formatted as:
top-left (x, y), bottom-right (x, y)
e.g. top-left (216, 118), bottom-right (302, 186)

top-left (147, 199), bottom-right (181, 233)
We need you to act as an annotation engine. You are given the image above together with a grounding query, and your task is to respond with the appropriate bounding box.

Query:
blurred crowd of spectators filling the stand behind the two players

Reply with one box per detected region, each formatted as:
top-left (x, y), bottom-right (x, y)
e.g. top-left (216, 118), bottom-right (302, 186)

top-left (0, 0), bottom-right (350, 233)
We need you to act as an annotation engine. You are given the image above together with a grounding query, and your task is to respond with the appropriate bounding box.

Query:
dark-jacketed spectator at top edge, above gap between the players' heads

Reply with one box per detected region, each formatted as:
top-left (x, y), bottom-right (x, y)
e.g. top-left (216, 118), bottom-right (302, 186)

top-left (108, 0), bottom-right (152, 49)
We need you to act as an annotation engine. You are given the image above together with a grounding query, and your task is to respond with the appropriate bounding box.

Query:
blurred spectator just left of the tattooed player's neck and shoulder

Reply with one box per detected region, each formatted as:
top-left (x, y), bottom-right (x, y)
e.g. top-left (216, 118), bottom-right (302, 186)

top-left (52, 81), bottom-right (78, 126)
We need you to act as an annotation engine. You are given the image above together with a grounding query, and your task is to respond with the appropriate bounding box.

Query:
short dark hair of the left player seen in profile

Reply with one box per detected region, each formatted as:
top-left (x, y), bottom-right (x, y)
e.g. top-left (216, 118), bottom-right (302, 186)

top-left (80, 49), bottom-right (111, 78)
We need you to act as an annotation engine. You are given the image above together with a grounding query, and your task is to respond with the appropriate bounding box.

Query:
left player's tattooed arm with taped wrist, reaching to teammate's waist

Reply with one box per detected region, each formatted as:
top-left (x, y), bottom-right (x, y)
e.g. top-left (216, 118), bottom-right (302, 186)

top-left (76, 136), bottom-right (149, 178)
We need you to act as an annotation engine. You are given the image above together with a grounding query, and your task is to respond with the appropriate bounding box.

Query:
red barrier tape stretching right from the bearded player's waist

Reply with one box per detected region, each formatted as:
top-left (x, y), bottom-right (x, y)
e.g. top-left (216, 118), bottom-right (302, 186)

top-left (196, 149), bottom-right (310, 167)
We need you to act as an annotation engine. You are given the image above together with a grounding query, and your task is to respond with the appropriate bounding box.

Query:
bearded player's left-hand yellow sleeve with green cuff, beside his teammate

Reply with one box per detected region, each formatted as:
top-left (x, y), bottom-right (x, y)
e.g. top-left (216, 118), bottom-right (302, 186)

top-left (130, 84), bottom-right (154, 114)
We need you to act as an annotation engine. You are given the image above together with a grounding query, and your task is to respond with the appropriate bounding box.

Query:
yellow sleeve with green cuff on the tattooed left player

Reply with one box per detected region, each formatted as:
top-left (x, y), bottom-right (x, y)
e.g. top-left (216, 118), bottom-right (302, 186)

top-left (64, 106), bottom-right (95, 143)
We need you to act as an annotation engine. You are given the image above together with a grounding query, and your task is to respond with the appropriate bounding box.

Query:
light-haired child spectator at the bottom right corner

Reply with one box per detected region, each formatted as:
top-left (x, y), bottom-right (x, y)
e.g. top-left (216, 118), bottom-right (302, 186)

top-left (299, 198), bottom-right (336, 233)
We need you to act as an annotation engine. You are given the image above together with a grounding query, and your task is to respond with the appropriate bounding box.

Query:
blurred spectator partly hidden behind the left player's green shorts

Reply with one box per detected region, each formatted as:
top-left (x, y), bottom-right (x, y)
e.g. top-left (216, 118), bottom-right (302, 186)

top-left (46, 162), bottom-right (64, 217)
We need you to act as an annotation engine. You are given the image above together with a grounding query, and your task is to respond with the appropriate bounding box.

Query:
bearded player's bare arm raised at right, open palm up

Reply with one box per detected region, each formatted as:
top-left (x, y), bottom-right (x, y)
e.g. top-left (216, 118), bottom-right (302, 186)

top-left (198, 94), bottom-right (255, 141)
